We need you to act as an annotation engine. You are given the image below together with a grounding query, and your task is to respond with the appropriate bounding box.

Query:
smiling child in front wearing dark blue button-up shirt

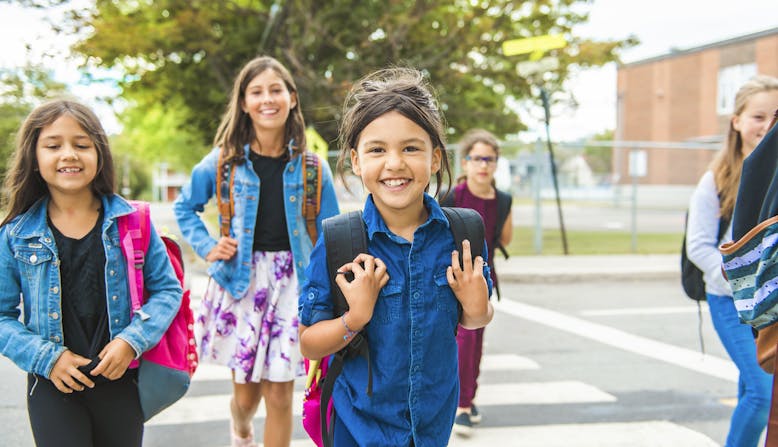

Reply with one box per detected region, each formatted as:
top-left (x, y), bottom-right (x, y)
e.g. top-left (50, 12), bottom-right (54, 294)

top-left (299, 68), bottom-right (493, 447)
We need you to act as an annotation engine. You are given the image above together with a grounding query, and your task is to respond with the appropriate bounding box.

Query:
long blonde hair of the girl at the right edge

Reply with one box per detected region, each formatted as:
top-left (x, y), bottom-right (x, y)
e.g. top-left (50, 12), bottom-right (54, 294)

top-left (710, 75), bottom-right (778, 217)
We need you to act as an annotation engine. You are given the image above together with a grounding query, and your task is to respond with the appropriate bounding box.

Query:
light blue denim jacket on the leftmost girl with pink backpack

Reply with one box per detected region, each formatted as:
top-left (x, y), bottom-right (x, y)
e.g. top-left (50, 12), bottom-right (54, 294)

top-left (0, 195), bottom-right (182, 378)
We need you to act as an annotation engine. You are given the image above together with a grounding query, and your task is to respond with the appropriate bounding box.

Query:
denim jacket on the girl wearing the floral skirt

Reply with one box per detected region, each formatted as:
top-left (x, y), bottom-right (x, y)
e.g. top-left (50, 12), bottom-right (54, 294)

top-left (173, 142), bottom-right (340, 299)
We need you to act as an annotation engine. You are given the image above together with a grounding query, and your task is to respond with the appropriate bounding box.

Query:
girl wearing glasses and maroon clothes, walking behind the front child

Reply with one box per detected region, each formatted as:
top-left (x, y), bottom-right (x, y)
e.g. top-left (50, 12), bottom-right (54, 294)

top-left (442, 129), bottom-right (513, 436)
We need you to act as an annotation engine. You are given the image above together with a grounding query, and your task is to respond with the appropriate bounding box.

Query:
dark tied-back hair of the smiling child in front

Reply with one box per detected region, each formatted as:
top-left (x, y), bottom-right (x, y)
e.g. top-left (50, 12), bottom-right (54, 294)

top-left (337, 68), bottom-right (451, 195)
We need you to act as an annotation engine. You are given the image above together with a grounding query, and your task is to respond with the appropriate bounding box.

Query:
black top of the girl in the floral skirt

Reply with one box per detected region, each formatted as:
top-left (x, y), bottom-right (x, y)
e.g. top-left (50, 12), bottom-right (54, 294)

top-left (249, 151), bottom-right (290, 251)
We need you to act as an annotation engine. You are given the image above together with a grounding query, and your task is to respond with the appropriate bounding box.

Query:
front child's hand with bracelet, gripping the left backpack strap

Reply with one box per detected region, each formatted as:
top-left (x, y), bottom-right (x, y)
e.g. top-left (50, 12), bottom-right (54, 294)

top-left (335, 253), bottom-right (389, 331)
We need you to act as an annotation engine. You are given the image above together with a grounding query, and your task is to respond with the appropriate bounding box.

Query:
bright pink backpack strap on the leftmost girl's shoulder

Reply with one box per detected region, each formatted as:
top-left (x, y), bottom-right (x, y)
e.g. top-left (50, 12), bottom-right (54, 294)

top-left (117, 200), bottom-right (151, 312)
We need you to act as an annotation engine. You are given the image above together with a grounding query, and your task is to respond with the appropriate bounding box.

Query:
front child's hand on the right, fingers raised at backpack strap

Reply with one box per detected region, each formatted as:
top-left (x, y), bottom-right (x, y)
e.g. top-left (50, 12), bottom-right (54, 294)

top-left (446, 239), bottom-right (492, 327)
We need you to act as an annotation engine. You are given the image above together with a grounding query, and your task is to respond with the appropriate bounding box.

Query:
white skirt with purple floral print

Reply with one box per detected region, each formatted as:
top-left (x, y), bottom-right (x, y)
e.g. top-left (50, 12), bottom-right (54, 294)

top-left (195, 251), bottom-right (305, 383)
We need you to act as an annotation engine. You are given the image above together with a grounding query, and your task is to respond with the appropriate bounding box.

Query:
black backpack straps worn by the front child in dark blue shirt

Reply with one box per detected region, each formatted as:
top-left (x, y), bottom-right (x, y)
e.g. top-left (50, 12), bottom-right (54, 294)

top-left (319, 207), bottom-right (484, 447)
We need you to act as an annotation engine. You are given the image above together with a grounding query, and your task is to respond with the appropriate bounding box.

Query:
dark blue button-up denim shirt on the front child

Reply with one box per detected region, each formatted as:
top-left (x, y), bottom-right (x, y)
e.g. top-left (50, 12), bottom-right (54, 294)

top-left (299, 194), bottom-right (491, 447)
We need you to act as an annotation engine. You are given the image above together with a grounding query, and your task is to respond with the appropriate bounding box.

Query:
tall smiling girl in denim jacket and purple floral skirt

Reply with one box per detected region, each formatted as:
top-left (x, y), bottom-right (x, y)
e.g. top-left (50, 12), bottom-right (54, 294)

top-left (174, 57), bottom-right (338, 446)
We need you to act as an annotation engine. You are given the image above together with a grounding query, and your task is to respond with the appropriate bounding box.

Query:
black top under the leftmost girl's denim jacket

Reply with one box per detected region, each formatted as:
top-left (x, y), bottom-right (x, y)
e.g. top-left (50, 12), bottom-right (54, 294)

top-left (49, 209), bottom-right (110, 358)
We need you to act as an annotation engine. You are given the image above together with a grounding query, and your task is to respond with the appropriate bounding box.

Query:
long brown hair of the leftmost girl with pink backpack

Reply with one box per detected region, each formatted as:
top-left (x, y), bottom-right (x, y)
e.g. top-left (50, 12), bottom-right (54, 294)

top-left (0, 99), bottom-right (115, 225)
